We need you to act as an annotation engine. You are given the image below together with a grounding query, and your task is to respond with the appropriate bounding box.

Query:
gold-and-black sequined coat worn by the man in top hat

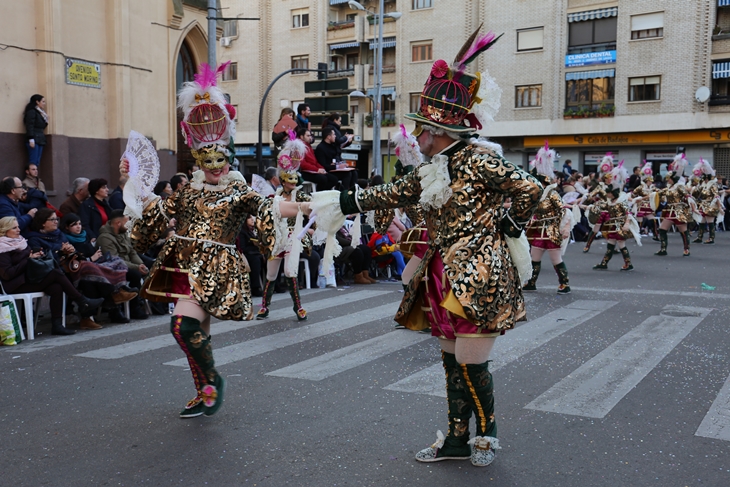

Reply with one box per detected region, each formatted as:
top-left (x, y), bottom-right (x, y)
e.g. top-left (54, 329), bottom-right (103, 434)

top-left (341, 141), bottom-right (542, 336)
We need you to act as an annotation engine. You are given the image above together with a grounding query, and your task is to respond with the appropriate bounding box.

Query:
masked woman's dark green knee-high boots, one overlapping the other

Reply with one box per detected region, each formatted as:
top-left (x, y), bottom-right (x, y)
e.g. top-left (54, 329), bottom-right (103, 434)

top-left (170, 315), bottom-right (226, 418)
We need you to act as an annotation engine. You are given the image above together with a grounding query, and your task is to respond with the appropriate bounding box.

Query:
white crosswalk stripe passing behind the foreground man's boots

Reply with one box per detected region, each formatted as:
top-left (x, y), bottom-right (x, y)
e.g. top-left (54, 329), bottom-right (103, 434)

top-left (386, 300), bottom-right (618, 397)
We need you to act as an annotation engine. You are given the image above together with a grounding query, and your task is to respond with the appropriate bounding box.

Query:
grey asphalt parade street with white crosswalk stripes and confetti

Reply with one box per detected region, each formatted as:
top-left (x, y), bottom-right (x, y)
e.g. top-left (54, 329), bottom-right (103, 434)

top-left (0, 232), bottom-right (730, 487)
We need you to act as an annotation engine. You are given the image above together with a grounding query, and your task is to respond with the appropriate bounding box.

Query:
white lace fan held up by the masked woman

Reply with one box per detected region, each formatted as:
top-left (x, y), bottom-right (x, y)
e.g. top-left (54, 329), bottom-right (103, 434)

top-left (122, 130), bottom-right (160, 219)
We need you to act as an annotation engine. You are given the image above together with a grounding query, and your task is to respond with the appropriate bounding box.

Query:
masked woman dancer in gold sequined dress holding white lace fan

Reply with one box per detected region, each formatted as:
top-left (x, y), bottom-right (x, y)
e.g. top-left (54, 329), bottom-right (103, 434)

top-left (120, 63), bottom-right (308, 418)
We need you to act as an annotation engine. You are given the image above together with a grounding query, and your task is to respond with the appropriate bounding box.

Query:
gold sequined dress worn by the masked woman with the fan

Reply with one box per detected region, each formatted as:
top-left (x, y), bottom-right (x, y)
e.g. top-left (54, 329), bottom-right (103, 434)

top-left (131, 178), bottom-right (275, 320)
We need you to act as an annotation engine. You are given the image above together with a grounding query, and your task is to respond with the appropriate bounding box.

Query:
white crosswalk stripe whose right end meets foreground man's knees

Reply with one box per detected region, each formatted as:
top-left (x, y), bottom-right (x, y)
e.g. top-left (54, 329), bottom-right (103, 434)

top-left (266, 330), bottom-right (431, 380)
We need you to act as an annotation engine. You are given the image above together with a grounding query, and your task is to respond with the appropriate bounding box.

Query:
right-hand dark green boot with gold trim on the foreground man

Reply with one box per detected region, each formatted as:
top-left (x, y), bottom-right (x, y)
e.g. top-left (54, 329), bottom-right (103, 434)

top-left (460, 362), bottom-right (499, 467)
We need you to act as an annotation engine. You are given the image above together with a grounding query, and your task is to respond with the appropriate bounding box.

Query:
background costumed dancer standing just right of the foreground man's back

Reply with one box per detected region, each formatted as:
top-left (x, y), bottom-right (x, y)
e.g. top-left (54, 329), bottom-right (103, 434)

top-left (522, 141), bottom-right (580, 294)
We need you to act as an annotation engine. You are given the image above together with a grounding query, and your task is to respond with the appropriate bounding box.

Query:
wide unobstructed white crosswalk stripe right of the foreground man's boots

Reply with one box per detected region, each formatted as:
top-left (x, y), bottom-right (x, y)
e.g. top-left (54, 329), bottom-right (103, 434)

top-left (526, 306), bottom-right (711, 418)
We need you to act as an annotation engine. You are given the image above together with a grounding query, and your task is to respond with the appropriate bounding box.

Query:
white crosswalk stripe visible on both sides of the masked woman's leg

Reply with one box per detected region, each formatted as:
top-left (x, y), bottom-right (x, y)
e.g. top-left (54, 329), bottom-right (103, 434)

top-left (77, 291), bottom-right (391, 359)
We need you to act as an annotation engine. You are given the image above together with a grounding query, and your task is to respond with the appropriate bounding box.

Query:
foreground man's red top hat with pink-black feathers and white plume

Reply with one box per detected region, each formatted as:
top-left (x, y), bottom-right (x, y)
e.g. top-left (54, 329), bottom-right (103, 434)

top-left (406, 25), bottom-right (502, 133)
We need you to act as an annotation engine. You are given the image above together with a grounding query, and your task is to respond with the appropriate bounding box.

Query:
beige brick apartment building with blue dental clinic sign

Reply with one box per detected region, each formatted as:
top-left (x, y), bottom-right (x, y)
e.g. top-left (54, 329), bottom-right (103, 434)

top-left (220, 0), bottom-right (730, 177)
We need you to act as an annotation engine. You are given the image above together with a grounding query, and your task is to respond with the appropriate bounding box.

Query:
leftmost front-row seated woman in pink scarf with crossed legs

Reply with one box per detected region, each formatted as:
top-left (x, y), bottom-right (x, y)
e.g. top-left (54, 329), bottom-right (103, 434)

top-left (0, 217), bottom-right (104, 335)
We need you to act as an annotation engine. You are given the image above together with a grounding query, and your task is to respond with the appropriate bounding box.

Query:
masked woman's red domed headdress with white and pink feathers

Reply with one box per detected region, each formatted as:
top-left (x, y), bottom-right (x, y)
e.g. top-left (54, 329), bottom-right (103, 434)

top-left (177, 61), bottom-right (236, 149)
